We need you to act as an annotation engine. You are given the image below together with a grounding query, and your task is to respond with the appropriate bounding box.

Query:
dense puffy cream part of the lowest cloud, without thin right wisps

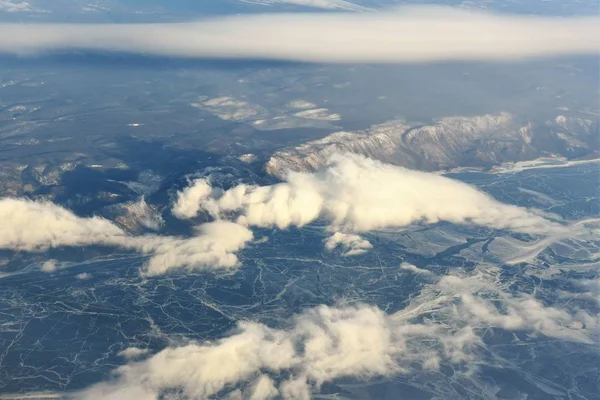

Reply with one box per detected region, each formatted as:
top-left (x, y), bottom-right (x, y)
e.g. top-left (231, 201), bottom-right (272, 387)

top-left (77, 305), bottom-right (476, 399)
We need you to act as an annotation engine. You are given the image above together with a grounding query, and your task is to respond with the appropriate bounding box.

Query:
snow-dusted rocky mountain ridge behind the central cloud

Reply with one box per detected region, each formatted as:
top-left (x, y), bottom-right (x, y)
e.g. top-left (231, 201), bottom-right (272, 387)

top-left (265, 113), bottom-right (598, 177)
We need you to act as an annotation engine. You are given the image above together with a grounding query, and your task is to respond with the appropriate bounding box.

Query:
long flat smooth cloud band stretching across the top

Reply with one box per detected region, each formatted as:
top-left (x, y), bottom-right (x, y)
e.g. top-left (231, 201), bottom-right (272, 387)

top-left (0, 6), bottom-right (600, 63)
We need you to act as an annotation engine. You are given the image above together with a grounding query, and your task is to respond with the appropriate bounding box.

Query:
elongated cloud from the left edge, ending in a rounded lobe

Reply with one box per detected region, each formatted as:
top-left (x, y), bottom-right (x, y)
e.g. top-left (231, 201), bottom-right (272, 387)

top-left (0, 199), bottom-right (252, 275)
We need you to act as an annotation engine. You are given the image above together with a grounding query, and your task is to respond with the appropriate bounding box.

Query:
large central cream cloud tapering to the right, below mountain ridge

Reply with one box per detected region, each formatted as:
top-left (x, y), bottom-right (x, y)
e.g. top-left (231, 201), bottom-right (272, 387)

top-left (189, 154), bottom-right (566, 234)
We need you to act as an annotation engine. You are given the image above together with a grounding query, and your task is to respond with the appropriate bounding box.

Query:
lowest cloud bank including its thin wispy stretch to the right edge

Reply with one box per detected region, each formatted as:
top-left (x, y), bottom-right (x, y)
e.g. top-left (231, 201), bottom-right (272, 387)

top-left (76, 280), bottom-right (598, 399)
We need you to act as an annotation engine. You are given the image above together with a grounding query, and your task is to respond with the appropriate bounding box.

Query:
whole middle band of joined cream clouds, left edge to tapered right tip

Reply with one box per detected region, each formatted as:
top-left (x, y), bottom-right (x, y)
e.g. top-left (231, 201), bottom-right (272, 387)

top-left (0, 154), bottom-right (569, 275)
